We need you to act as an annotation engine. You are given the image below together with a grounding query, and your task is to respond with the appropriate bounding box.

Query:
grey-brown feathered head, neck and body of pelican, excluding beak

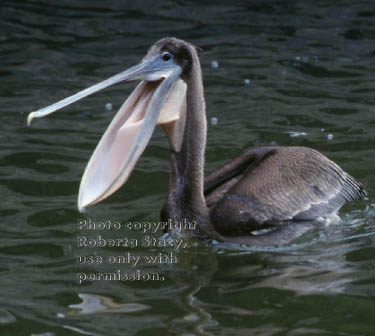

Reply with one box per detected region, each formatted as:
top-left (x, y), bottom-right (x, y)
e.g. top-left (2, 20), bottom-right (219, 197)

top-left (159, 38), bottom-right (366, 245)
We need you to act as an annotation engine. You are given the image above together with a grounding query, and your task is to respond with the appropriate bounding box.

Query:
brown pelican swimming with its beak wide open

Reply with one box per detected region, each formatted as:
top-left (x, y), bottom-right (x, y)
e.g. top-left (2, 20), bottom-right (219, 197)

top-left (28, 38), bottom-right (366, 245)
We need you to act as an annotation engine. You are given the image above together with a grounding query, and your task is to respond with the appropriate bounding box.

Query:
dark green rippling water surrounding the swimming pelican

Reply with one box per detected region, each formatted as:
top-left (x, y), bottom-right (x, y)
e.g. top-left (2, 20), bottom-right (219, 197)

top-left (0, 0), bottom-right (375, 336)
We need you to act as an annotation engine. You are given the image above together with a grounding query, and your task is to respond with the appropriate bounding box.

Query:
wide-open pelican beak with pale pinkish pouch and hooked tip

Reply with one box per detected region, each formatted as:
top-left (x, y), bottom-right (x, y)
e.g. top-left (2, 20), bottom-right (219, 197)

top-left (27, 55), bottom-right (186, 211)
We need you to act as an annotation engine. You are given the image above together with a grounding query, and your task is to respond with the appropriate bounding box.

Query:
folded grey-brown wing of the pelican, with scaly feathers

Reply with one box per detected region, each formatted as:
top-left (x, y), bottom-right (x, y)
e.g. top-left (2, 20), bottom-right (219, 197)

top-left (210, 147), bottom-right (366, 234)
